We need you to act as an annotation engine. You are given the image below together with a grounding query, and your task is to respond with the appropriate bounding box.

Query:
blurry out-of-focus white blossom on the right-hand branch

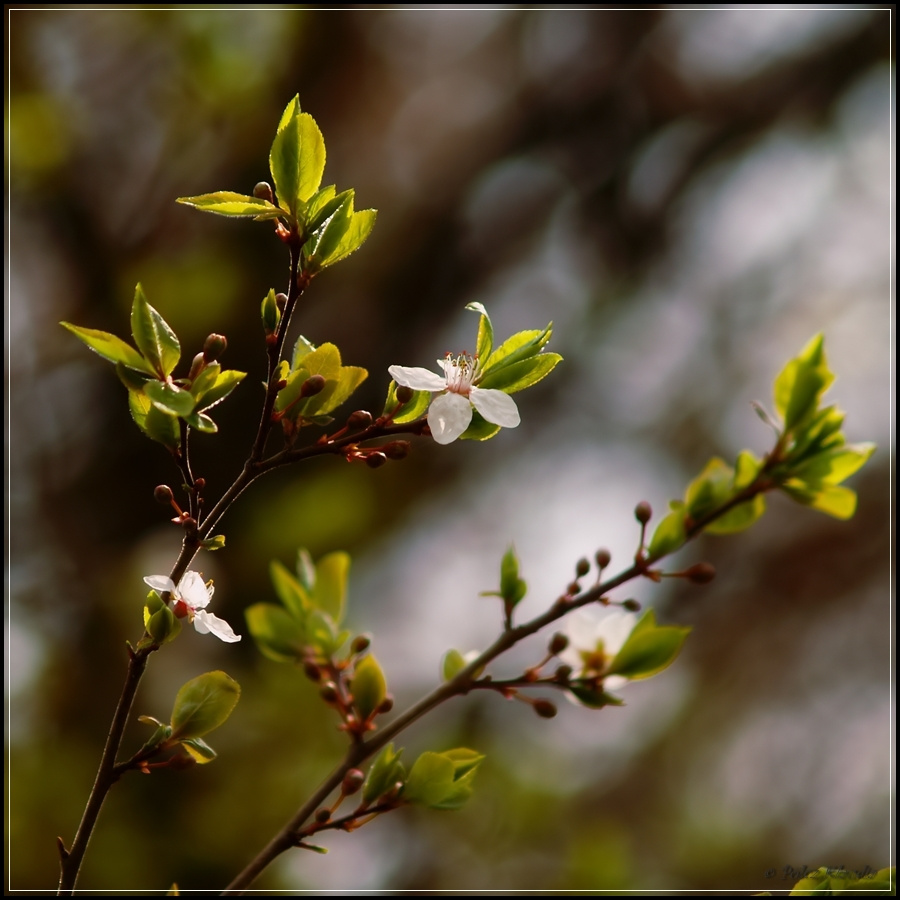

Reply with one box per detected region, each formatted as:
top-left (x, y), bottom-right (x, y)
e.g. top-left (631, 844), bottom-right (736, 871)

top-left (559, 609), bottom-right (638, 691)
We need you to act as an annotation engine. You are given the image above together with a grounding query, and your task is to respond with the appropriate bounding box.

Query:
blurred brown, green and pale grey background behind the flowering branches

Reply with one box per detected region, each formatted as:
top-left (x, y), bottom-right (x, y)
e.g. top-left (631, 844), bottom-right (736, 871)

top-left (6, 7), bottom-right (893, 893)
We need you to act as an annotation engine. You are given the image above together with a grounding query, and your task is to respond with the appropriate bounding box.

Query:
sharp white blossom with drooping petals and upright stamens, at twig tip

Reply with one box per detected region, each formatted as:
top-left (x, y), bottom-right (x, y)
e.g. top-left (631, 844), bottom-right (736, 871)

top-left (388, 353), bottom-right (520, 444)
